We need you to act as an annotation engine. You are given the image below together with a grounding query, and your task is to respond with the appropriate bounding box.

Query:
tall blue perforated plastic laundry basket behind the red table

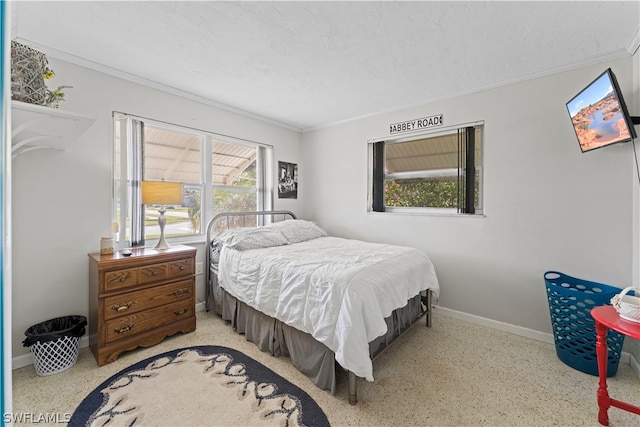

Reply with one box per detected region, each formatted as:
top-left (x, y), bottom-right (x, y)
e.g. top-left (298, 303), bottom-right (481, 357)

top-left (544, 271), bottom-right (624, 377)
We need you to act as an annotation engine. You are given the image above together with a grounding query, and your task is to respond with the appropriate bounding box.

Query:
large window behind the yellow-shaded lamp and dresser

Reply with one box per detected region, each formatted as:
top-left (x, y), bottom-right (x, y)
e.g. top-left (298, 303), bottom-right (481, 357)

top-left (114, 113), bottom-right (273, 246)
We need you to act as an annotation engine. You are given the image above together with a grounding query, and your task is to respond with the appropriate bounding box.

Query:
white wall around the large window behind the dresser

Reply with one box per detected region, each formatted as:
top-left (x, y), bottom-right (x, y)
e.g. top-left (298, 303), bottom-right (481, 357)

top-left (12, 58), bottom-right (302, 357)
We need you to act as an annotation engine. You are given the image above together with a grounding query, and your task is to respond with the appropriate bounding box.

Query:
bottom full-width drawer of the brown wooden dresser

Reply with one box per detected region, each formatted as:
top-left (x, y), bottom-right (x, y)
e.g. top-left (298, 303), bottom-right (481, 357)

top-left (105, 298), bottom-right (194, 343)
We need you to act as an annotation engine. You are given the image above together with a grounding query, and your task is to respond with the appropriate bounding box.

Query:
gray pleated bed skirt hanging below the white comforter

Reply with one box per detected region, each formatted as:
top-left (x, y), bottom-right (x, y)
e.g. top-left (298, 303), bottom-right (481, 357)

top-left (210, 271), bottom-right (430, 394)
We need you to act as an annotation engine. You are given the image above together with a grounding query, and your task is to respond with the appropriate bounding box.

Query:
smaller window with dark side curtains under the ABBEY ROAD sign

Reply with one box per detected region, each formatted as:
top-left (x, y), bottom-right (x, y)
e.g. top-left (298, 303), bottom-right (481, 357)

top-left (369, 123), bottom-right (483, 214)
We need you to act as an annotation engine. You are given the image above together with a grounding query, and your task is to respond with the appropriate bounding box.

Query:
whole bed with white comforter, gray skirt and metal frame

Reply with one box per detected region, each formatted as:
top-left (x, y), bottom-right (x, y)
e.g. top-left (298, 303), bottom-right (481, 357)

top-left (206, 211), bottom-right (439, 404)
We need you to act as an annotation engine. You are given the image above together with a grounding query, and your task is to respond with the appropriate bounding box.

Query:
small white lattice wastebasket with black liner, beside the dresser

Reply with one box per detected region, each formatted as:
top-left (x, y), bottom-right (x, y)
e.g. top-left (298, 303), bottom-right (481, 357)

top-left (22, 316), bottom-right (87, 376)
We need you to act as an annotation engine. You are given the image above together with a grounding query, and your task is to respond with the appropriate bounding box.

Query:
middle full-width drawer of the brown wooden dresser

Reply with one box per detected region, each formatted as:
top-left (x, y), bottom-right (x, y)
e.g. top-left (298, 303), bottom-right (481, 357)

top-left (104, 279), bottom-right (193, 320)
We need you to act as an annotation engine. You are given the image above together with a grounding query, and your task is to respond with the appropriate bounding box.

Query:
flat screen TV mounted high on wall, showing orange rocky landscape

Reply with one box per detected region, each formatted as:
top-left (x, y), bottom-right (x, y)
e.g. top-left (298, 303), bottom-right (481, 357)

top-left (567, 68), bottom-right (636, 153)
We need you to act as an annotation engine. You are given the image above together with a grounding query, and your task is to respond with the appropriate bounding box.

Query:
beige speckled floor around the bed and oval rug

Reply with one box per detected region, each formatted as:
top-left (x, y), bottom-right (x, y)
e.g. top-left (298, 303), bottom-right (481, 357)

top-left (13, 312), bottom-right (640, 426)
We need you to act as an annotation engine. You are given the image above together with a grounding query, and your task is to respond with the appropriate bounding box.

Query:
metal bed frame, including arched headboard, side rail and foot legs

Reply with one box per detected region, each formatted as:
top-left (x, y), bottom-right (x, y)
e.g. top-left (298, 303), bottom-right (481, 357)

top-left (205, 210), bottom-right (433, 405)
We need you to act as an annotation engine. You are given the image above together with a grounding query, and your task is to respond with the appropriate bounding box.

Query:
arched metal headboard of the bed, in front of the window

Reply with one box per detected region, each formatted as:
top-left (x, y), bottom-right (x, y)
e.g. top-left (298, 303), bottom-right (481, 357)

top-left (204, 211), bottom-right (296, 311)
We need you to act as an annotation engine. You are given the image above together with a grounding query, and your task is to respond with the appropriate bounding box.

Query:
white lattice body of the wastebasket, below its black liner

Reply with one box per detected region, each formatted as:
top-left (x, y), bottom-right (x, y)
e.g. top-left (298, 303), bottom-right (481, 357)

top-left (31, 336), bottom-right (80, 376)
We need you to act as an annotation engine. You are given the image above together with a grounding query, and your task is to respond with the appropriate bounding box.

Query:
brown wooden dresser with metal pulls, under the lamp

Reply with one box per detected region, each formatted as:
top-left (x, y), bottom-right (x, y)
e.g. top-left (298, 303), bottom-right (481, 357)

top-left (88, 245), bottom-right (196, 366)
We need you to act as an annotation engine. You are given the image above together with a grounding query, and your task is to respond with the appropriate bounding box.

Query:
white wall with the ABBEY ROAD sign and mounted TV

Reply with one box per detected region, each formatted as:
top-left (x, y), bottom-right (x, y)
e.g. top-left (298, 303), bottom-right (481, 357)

top-left (301, 58), bottom-right (635, 338)
